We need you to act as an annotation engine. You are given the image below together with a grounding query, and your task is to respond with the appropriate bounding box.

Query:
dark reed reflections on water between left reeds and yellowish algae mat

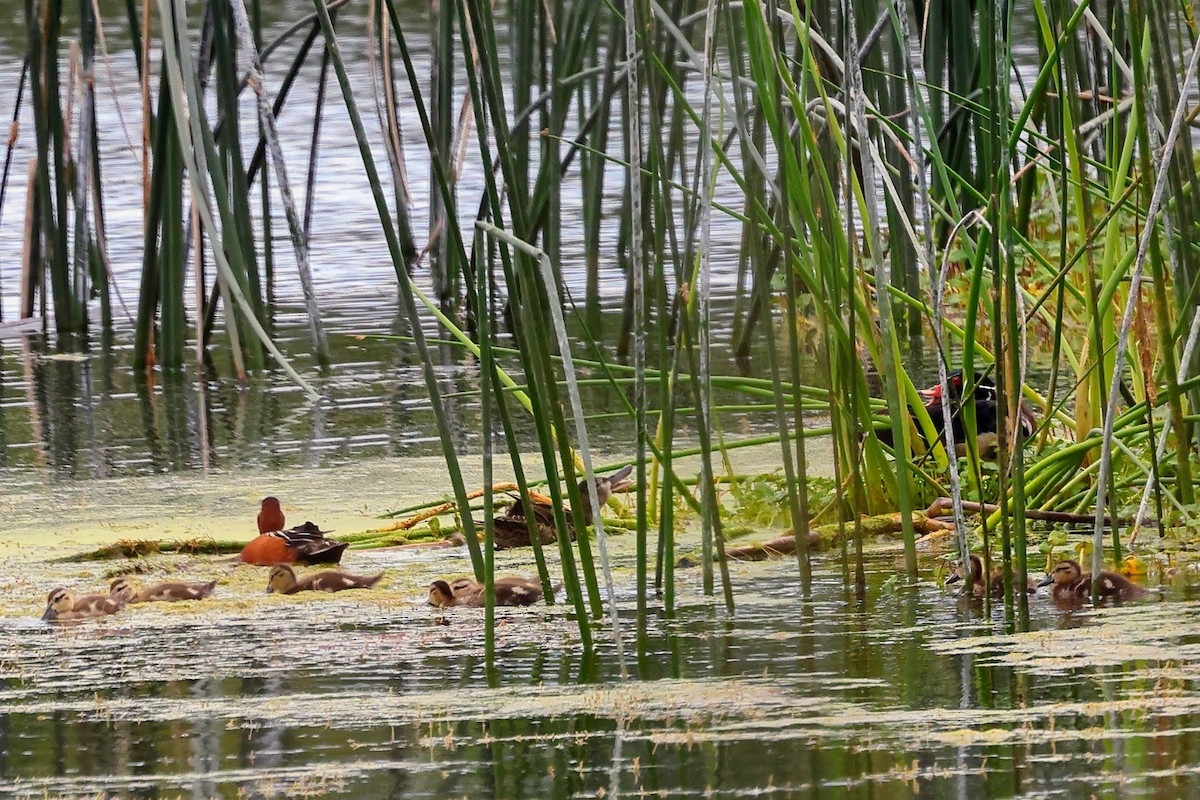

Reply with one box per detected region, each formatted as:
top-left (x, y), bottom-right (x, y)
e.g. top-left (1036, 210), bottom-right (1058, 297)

top-left (0, 299), bottom-right (774, 480)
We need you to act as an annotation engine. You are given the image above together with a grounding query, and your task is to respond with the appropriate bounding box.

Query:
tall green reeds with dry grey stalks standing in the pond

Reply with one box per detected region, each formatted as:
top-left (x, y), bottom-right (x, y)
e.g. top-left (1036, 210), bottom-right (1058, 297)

top-left (7, 0), bottom-right (1200, 638)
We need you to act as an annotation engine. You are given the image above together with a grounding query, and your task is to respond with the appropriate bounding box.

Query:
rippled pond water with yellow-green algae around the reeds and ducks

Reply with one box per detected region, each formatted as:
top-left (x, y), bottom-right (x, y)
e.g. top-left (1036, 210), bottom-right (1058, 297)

top-left (0, 1), bottom-right (1200, 799)
